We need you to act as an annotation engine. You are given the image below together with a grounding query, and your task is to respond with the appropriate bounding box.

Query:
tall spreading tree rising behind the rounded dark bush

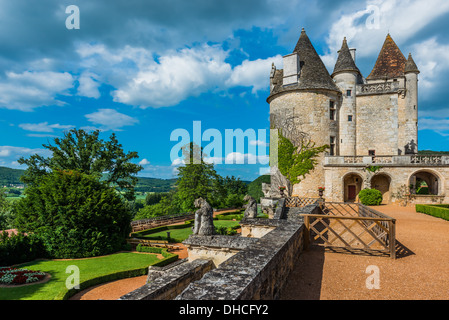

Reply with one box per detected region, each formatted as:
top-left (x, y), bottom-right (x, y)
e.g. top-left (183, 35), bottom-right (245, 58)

top-left (18, 129), bottom-right (142, 199)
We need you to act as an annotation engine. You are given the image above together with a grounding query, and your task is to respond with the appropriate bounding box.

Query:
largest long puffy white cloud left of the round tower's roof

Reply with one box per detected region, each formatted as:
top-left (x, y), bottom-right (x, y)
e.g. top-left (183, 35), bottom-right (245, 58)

top-left (77, 44), bottom-right (282, 108)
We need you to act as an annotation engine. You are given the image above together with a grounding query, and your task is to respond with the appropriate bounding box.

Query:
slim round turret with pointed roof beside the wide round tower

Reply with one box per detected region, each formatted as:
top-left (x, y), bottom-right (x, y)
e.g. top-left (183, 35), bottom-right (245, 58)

top-left (332, 38), bottom-right (360, 156)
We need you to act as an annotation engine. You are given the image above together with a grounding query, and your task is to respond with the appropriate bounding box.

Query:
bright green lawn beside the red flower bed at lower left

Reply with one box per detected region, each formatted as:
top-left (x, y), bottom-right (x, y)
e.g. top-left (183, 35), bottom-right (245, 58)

top-left (0, 252), bottom-right (164, 300)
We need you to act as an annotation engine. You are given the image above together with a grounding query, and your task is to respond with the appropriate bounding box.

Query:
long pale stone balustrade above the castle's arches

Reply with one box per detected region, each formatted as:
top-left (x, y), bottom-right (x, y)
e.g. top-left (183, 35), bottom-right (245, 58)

top-left (324, 155), bottom-right (449, 167)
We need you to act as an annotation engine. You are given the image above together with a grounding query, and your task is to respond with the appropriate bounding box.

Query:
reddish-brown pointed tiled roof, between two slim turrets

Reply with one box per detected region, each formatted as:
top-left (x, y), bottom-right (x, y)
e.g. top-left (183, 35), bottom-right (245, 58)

top-left (366, 34), bottom-right (407, 80)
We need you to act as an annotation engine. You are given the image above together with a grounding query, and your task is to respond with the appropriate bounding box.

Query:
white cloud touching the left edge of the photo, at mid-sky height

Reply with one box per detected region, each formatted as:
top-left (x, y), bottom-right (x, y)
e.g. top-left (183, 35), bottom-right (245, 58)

top-left (0, 71), bottom-right (74, 111)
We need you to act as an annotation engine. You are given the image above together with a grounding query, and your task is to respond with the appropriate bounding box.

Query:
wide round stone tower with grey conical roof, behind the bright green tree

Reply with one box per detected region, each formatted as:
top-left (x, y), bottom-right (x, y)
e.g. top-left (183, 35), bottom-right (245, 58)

top-left (267, 29), bottom-right (341, 197)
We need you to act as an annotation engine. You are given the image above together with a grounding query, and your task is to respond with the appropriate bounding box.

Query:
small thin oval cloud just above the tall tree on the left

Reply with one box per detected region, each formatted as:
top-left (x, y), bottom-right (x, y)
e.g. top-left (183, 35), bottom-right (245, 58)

top-left (85, 109), bottom-right (139, 131)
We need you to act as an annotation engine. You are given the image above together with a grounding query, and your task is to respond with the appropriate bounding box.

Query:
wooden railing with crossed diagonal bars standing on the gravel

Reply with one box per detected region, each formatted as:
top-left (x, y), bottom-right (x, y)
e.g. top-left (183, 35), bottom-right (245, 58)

top-left (302, 202), bottom-right (396, 259)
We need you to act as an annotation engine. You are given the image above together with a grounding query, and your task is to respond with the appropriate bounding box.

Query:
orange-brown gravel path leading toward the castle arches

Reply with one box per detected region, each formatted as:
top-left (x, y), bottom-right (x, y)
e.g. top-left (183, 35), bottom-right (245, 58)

top-left (281, 205), bottom-right (449, 300)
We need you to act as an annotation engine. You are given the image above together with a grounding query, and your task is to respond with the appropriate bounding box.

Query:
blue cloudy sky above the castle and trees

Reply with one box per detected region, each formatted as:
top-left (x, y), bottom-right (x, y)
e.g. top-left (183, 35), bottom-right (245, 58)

top-left (0, 0), bottom-right (449, 180)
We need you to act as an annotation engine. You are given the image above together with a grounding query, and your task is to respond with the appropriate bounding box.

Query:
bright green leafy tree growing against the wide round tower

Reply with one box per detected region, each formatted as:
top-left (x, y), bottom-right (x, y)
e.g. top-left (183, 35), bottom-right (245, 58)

top-left (278, 132), bottom-right (329, 195)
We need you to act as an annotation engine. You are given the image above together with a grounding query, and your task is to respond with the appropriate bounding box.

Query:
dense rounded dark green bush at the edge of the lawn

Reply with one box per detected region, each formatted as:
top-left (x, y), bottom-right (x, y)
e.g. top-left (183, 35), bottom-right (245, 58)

top-left (16, 170), bottom-right (131, 258)
